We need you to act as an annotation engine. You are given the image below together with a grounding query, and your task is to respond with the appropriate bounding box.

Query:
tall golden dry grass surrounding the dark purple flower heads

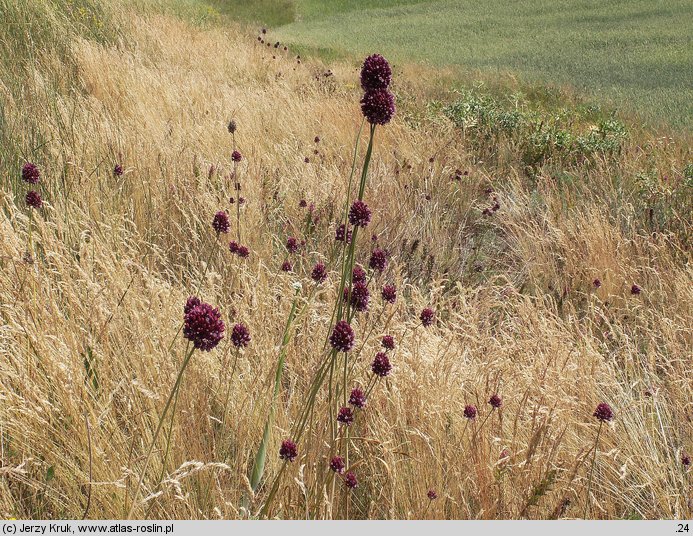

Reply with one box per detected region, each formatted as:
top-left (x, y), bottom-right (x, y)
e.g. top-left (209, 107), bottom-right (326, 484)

top-left (0, 0), bottom-right (693, 519)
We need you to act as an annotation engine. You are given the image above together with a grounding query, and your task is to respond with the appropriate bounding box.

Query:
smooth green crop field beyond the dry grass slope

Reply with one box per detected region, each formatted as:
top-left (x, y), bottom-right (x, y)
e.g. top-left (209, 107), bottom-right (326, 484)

top-left (215, 0), bottom-right (693, 128)
